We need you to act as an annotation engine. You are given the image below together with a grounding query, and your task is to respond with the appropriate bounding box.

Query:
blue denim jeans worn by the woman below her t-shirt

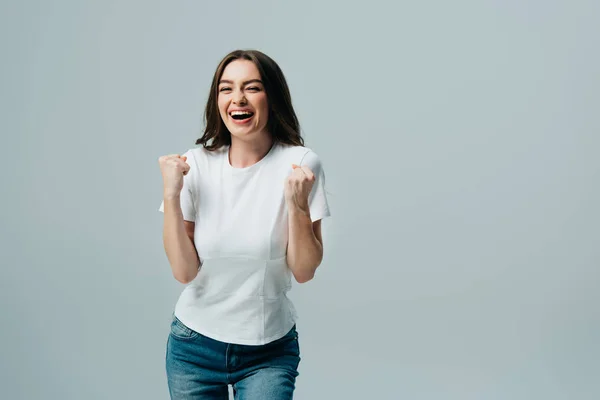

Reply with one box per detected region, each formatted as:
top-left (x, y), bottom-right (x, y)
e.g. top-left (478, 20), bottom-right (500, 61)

top-left (166, 316), bottom-right (300, 400)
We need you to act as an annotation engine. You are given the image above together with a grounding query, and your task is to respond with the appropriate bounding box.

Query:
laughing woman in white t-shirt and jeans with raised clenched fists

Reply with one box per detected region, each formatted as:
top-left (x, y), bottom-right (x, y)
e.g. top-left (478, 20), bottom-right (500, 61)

top-left (159, 50), bottom-right (330, 400)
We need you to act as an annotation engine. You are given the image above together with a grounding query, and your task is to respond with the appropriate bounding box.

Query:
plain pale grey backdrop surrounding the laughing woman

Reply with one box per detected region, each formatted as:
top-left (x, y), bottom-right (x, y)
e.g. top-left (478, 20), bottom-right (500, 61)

top-left (0, 0), bottom-right (600, 400)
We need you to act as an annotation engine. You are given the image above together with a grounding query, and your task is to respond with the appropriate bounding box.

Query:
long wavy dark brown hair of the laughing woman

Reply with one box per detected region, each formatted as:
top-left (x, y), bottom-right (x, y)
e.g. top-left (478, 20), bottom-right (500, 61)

top-left (196, 50), bottom-right (304, 151)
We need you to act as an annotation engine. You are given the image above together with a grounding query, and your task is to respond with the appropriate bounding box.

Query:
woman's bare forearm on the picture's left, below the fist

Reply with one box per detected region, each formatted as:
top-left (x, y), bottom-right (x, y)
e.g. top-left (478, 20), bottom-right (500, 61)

top-left (163, 196), bottom-right (200, 283)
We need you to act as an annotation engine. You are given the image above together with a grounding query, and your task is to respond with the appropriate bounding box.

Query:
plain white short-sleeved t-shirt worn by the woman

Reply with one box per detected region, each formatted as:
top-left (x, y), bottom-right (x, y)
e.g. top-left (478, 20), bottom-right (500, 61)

top-left (160, 143), bottom-right (330, 345)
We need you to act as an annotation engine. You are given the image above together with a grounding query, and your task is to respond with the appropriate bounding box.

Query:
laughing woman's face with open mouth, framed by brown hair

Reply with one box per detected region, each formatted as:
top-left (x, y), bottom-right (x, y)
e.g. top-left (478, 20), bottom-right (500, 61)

top-left (217, 60), bottom-right (269, 140)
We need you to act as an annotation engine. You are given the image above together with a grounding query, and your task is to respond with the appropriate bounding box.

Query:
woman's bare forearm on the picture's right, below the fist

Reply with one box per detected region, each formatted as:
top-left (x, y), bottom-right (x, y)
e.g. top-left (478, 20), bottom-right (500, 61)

top-left (287, 208), bottom-right (323, 283)
